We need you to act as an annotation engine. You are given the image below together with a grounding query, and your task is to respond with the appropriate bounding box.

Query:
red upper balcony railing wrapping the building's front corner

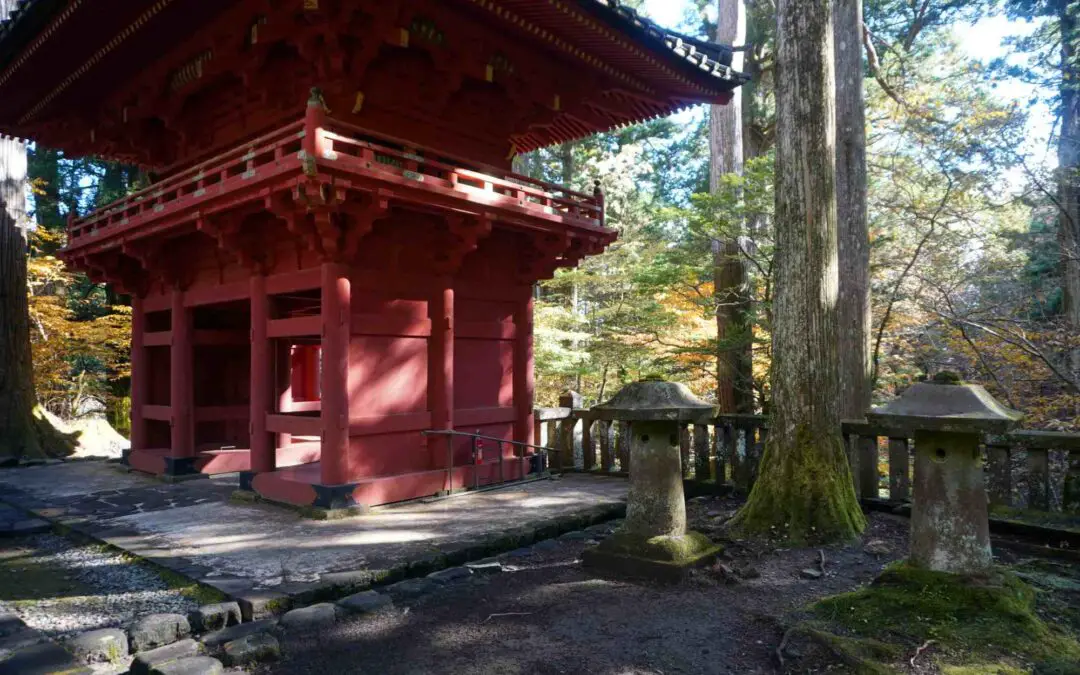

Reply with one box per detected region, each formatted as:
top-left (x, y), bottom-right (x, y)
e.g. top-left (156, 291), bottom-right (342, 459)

top-left (68, 118), bottom-right (604, 249)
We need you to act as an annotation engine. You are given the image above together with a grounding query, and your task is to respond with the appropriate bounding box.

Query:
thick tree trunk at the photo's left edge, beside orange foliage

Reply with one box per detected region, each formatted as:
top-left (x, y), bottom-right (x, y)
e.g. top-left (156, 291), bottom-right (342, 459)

top-left (0, 132), bottom-right (42, 458)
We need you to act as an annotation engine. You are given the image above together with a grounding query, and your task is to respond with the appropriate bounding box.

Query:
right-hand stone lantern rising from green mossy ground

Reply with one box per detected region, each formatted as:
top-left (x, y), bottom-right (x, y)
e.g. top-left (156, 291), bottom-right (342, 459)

top-left (866, 373), bottom-right (1022, 573)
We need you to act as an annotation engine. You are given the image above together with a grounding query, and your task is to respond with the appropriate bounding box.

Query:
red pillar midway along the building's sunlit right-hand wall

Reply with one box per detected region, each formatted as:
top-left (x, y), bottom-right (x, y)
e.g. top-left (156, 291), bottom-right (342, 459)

top-left (428, 278), bottom-right (454, 463)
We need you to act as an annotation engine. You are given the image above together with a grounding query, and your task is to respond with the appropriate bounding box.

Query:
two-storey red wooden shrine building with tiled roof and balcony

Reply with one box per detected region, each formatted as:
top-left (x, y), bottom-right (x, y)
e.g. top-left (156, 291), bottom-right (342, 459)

top-left (0, 0), bottom-right (743, 508)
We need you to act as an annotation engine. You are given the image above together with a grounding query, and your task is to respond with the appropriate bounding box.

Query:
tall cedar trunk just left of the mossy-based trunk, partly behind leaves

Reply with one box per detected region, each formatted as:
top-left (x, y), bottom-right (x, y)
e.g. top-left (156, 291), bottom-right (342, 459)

top-left (708, 0), bottom-right (754, 413)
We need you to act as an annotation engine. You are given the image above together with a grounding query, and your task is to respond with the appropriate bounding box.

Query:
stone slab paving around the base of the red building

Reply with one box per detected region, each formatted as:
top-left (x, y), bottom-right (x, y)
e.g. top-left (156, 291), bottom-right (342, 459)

top-left (0, 461), bottom-right (626, 602)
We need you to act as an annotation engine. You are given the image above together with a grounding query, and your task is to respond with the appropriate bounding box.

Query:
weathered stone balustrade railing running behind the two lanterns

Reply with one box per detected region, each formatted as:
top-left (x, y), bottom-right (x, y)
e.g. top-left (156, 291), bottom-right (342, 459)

top-left (535, 407), bottom-right (1080, 513)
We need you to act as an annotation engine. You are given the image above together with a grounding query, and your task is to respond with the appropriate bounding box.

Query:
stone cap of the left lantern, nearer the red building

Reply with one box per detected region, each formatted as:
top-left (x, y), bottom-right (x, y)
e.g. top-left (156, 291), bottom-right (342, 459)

top-left (593, 377), bottom-right (716, 422)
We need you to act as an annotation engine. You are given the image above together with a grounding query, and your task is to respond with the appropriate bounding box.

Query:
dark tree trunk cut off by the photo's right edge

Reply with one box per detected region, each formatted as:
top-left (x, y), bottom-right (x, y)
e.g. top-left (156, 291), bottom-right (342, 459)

top-left (1057, 2), bottom-right (1080, 395)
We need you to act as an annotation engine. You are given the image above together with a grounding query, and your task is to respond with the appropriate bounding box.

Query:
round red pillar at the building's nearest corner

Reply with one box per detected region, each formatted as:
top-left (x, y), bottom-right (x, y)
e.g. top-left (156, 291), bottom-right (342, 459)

top-left (320, 262), bottom-right (352, 485)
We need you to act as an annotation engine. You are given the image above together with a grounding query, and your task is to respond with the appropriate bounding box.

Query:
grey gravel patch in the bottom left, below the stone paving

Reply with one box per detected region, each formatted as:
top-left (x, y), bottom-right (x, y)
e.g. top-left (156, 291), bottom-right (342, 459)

top-left (0, 535), bottom-right (197, 638)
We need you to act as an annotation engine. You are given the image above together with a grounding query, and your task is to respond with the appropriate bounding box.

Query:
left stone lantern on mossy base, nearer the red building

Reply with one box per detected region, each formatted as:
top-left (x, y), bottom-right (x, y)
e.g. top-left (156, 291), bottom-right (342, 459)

top-left (582, 379), bottom-right (720, 581)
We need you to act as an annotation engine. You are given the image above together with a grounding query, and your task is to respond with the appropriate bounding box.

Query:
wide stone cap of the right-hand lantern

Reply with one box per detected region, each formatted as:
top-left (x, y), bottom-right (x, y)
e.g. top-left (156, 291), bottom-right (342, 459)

top-left (866, 374), bottom-right (1024, 433)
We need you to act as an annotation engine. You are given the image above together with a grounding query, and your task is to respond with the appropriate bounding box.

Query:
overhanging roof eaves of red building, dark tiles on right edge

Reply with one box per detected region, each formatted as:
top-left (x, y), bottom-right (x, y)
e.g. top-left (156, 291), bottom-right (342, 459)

top-left (0, 0), bottom-right (747, 158)
